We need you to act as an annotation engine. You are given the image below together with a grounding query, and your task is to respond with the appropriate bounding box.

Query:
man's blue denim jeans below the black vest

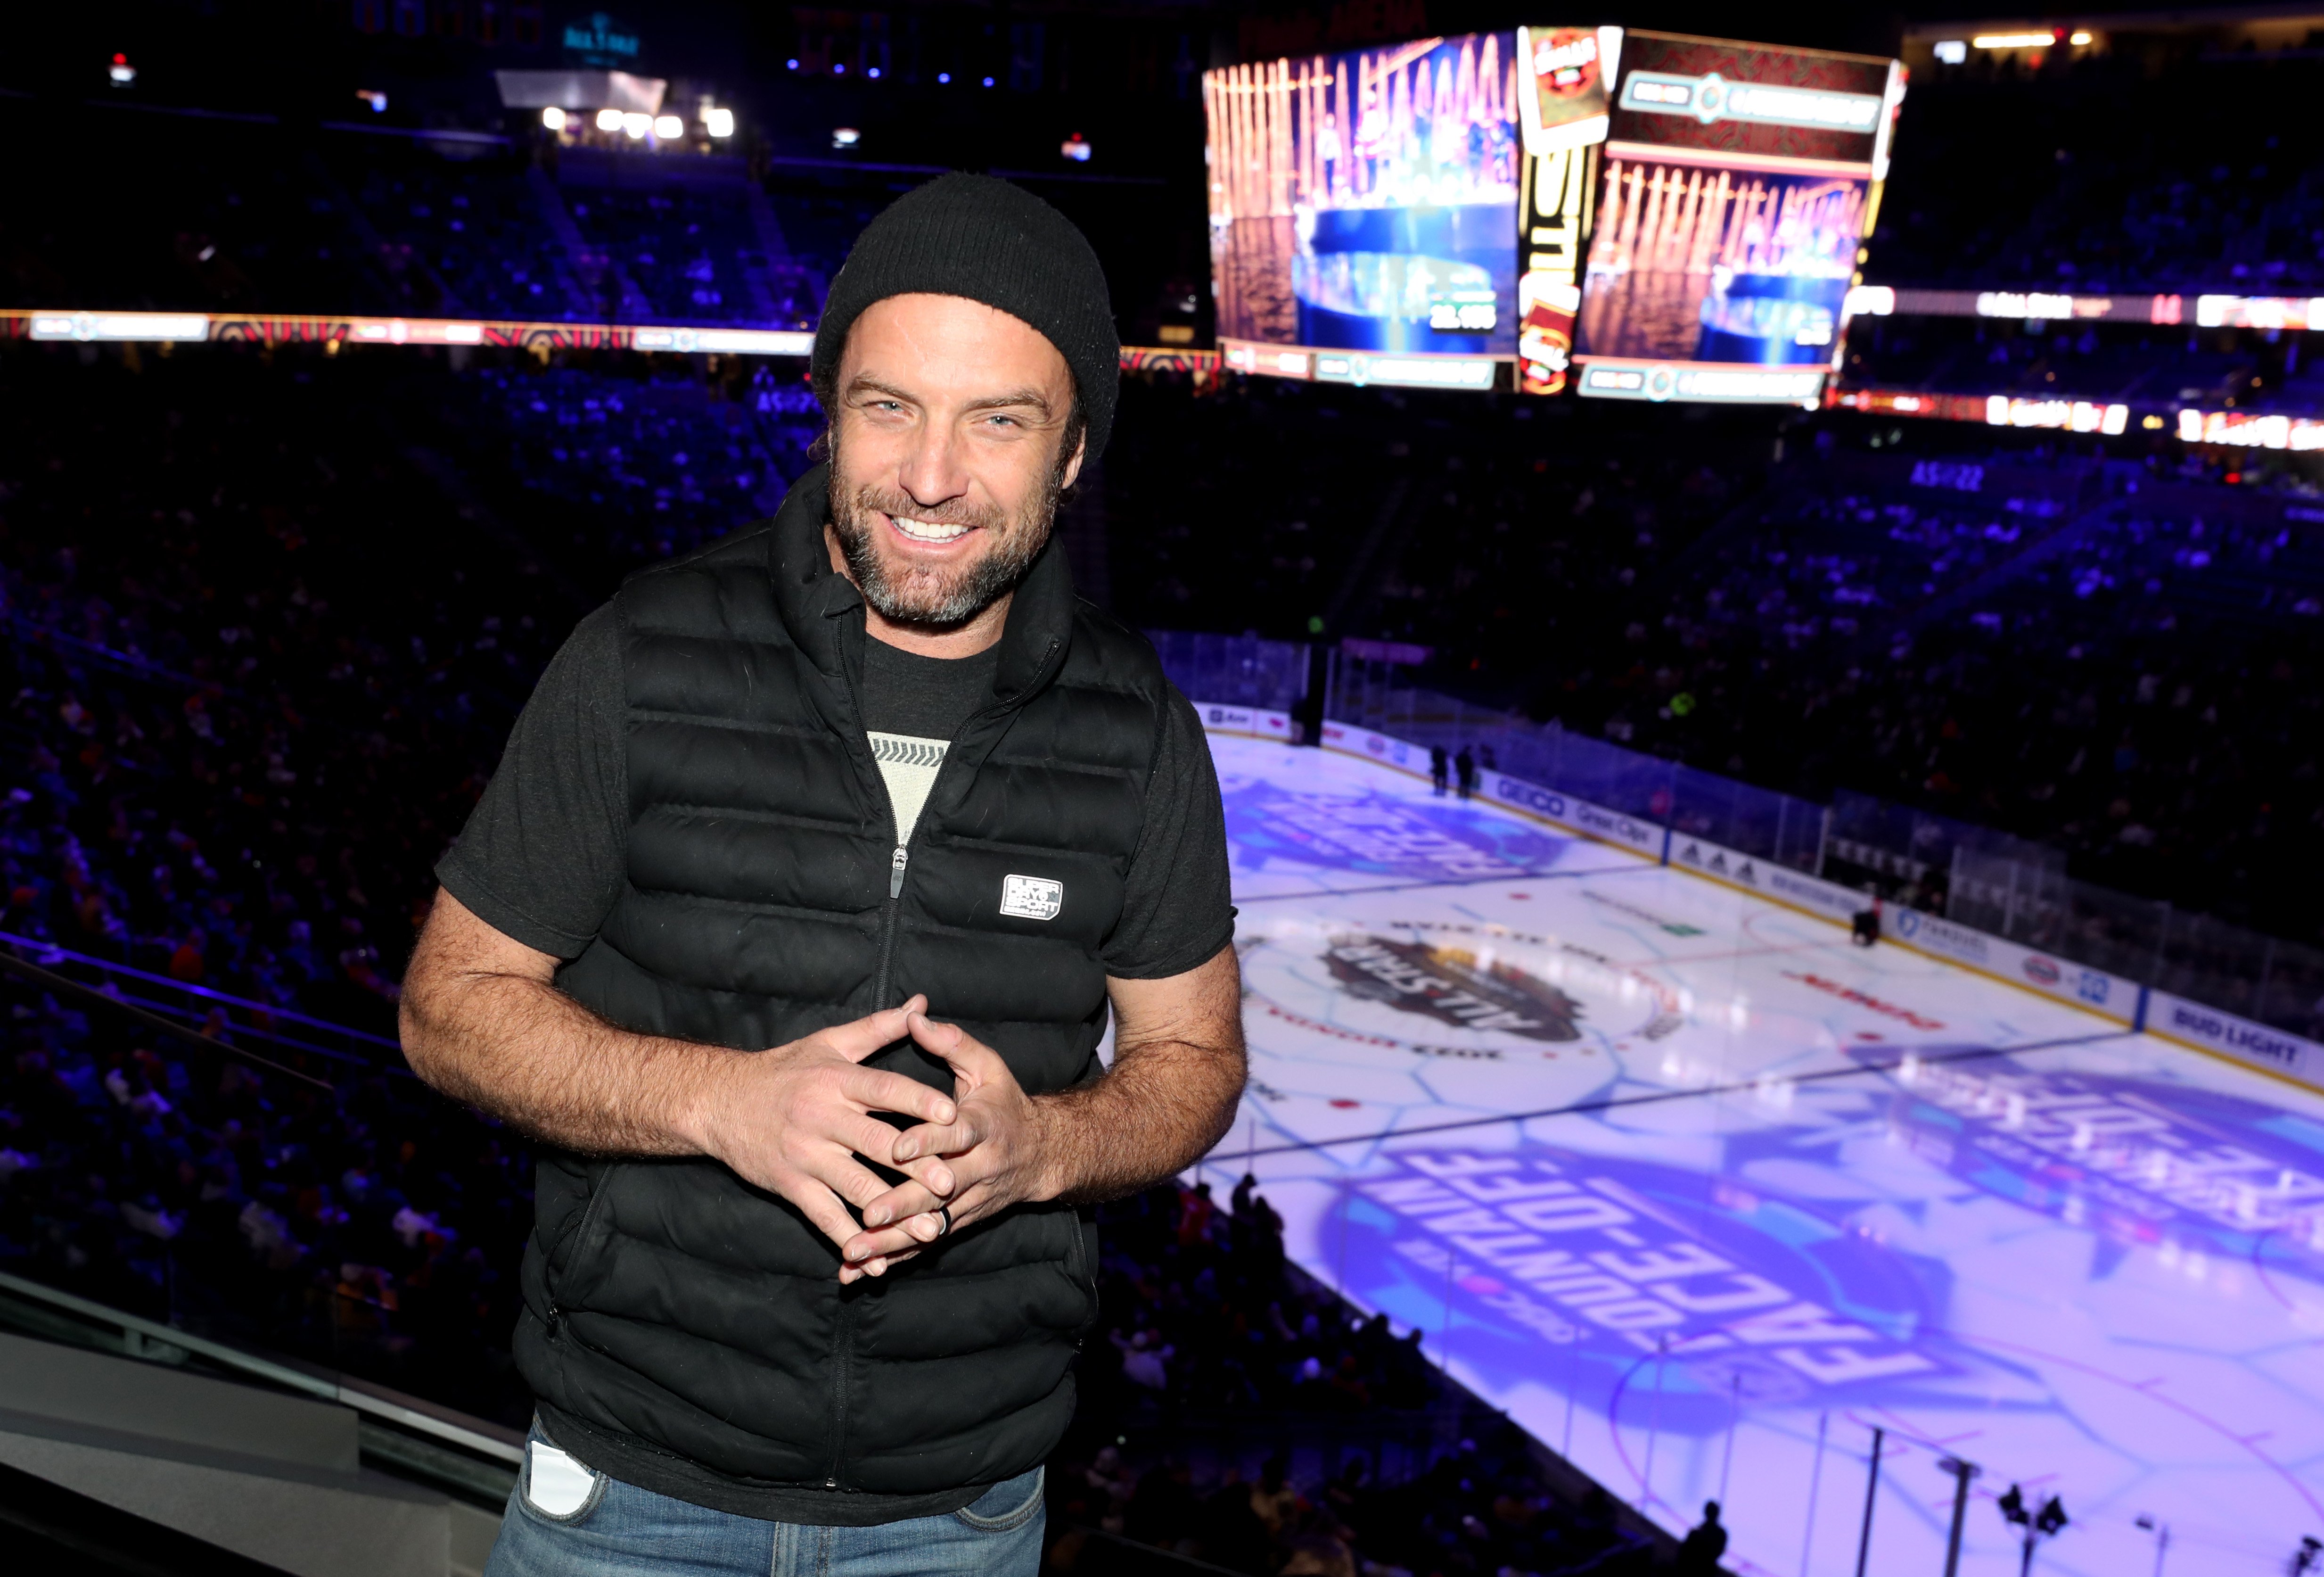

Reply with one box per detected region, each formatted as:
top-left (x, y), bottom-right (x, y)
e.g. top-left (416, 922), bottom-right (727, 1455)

top-left (484, 1430), bottom-right (1046, 1577)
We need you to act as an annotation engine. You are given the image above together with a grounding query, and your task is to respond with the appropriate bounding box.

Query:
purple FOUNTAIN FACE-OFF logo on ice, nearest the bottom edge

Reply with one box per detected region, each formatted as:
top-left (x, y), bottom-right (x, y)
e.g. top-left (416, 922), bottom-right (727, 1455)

top-left (1325, 1144), bottom-right (1952, 1430)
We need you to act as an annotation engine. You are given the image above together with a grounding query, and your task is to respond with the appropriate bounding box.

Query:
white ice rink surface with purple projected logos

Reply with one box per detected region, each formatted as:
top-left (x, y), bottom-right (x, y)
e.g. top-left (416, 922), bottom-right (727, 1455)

top-left (1204, 735), bottom-right (2324, 1577)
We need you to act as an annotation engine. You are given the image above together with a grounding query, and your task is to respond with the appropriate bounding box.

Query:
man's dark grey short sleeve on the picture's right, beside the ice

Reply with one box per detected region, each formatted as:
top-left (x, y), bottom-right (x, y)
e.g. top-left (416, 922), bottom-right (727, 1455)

top-left (1104, 686), bottom-right (1234, 979)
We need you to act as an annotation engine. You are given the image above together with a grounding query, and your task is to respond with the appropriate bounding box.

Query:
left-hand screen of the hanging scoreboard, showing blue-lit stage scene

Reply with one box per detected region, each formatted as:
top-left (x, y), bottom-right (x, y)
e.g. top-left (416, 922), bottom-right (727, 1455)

top-left (1204, 33), bottom-right (1522, 388)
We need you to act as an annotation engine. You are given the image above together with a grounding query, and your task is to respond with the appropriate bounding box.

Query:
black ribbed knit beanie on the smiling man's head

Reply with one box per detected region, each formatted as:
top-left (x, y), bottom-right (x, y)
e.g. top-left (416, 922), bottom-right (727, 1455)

top-left (809, 170), bottom-right (1123, 461)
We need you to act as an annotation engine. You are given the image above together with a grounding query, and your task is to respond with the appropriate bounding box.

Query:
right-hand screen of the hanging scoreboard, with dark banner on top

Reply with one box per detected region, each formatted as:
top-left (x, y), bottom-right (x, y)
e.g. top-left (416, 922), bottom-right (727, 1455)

top-left (1573, 30), bottom-right (1903, 405)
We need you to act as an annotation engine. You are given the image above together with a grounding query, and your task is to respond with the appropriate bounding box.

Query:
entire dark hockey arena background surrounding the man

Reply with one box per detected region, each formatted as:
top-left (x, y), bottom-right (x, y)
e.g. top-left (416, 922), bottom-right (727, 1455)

top-left (0, 0), bottom-right (2324, 1577)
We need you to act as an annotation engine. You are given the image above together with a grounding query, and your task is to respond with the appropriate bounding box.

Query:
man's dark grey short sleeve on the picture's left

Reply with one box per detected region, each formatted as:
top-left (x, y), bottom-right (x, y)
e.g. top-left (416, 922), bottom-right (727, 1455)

top-left (437, 605), bottom-right (630, 958)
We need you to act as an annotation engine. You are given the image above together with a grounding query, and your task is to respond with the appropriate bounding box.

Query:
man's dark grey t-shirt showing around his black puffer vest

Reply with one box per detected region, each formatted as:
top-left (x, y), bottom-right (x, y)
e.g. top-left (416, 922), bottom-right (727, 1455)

top-left (437, 605), bottom-right (1234, 979)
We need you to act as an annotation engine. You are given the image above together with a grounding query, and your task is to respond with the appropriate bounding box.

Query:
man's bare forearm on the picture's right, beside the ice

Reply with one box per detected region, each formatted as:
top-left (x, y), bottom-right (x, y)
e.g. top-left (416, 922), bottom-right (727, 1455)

top-left (1034, 1035), bottom-right (1248, 1205)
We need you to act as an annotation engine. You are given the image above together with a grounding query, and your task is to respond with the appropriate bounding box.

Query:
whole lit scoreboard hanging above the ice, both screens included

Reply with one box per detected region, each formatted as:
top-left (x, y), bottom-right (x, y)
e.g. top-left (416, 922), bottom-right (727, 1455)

top-left (1204, 28), bottom-right (1903, 405)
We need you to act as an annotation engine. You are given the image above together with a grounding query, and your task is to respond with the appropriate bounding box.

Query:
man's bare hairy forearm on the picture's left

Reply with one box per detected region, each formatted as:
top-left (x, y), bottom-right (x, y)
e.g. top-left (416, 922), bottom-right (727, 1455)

top-left (402, 967), bottom-right (737, 1156)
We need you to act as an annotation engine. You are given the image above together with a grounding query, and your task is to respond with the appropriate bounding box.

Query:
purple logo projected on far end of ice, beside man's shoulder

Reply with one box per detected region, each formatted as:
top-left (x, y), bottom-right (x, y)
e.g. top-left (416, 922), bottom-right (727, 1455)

top-left (1223, 779), bottom-right (1571, 882)
